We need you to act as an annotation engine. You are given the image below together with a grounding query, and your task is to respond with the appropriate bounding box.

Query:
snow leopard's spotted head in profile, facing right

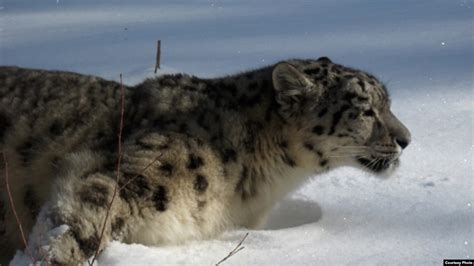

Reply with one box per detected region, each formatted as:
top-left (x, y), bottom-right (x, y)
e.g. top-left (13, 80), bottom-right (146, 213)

top-left (272, 57), bottom-right (411, 173)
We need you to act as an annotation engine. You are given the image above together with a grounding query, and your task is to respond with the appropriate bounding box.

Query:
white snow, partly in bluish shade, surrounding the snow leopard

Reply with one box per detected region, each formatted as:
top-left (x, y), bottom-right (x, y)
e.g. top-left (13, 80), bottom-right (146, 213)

top-left (0, 0), bottom-right (474, 265)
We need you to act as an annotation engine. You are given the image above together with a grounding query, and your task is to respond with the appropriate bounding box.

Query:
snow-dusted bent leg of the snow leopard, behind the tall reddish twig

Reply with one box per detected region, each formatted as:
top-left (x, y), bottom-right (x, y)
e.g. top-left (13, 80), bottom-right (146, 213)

top-left (16, 152), bottom-right (130, 265)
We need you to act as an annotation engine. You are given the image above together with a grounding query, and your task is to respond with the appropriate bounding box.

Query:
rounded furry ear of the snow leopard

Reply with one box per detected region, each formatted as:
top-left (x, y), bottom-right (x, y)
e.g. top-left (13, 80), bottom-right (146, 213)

top-left (272, 62), bottom-right (322, 118)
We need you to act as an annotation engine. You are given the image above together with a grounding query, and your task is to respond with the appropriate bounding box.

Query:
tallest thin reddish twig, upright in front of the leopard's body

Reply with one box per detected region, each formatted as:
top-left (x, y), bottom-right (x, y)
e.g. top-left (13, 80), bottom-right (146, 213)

top-left (89, 74), bottom-right (125, 265)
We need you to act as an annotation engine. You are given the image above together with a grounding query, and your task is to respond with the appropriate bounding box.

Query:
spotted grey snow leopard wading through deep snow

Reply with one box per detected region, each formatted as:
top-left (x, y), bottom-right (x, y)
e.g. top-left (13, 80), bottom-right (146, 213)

top-left (0, 57), bottom-right (411, 265)
